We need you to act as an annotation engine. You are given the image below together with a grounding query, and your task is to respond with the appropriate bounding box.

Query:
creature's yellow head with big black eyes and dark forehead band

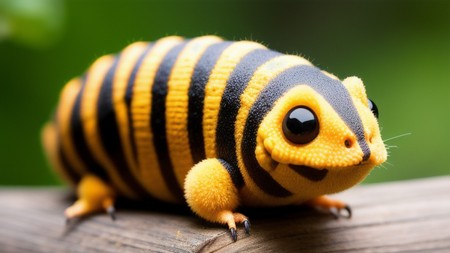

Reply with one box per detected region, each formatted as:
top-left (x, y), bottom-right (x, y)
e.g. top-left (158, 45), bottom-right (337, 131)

top-left (255, 72), bottom-right (387, 196)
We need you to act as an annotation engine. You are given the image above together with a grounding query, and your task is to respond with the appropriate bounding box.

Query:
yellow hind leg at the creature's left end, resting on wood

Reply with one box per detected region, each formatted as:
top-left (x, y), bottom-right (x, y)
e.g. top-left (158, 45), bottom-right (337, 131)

top-left (64, 175), bottom-right (115, 220)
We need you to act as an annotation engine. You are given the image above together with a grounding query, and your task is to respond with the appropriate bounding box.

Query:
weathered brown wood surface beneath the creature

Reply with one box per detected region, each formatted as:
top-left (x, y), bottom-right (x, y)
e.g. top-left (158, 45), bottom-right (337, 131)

top-left (0, 177), bottom-right (450, 252)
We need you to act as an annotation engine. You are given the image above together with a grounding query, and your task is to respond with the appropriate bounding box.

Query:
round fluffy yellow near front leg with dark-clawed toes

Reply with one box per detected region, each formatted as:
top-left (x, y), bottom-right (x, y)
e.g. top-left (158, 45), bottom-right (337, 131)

top-left (184, 159), bottom-right (250, 241)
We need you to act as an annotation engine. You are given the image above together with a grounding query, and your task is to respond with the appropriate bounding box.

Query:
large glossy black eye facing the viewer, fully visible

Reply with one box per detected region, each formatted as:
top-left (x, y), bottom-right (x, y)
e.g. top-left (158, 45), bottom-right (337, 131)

top-left (283, 106), bottom-right (319, 144)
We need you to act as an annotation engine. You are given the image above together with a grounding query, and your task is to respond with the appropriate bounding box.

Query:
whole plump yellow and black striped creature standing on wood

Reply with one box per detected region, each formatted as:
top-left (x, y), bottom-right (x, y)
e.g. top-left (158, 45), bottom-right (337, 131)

top-left (42, 36), bottom-right (387, 240)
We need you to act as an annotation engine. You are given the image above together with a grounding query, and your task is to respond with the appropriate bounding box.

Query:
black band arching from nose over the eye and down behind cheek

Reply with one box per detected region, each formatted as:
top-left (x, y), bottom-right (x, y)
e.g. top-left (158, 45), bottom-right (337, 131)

top-left (242, 65), bottom-right (367, 197)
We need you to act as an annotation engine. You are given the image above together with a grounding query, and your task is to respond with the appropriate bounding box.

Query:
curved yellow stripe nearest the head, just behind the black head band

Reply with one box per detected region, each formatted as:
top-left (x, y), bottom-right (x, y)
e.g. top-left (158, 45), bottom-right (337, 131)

top-left (235, 55), bottom-right (311, 200)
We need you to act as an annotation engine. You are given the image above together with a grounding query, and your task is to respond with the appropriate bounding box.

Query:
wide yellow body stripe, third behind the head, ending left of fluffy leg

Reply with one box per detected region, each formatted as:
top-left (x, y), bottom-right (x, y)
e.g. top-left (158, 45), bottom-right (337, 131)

top-left (166, 36), bottom-right (222, 185)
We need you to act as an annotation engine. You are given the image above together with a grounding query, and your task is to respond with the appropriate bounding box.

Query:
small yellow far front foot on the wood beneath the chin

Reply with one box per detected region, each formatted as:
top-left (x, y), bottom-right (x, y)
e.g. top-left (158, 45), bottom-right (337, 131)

top-left (305, 195), bottom-right (352, 219)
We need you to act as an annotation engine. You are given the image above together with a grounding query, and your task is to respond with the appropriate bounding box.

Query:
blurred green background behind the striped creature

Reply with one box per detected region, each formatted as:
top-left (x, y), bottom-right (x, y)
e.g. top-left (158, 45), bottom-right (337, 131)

top-left (0, 0), bottom-right (450, 185)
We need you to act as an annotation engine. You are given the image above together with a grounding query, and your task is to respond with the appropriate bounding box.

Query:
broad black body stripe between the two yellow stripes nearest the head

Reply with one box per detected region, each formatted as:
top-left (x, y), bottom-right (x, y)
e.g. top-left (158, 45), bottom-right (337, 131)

top-left (216, 49), bottom-right (281, 172)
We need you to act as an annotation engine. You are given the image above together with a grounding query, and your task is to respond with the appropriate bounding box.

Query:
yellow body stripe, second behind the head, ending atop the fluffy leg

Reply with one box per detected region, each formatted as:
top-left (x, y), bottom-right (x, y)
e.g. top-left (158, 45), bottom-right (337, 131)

top-left (203, 41), bottom-right (265, 158)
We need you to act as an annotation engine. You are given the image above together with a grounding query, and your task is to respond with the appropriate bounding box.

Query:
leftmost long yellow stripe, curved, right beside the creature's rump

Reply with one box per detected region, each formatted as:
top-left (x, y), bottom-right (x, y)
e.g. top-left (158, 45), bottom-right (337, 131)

top-left (57, 78), bottom-right (87, 175)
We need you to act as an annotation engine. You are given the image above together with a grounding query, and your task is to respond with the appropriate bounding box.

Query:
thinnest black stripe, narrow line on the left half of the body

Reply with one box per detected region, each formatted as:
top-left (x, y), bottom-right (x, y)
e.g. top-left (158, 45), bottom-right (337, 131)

top-left (125, 44), bottom-right (153, 167)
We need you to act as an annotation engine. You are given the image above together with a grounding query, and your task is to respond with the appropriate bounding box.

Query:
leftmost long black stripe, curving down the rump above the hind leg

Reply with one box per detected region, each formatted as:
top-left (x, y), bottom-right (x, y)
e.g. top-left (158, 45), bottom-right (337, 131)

top-left (70, 76), bottom-right (110, 183)
